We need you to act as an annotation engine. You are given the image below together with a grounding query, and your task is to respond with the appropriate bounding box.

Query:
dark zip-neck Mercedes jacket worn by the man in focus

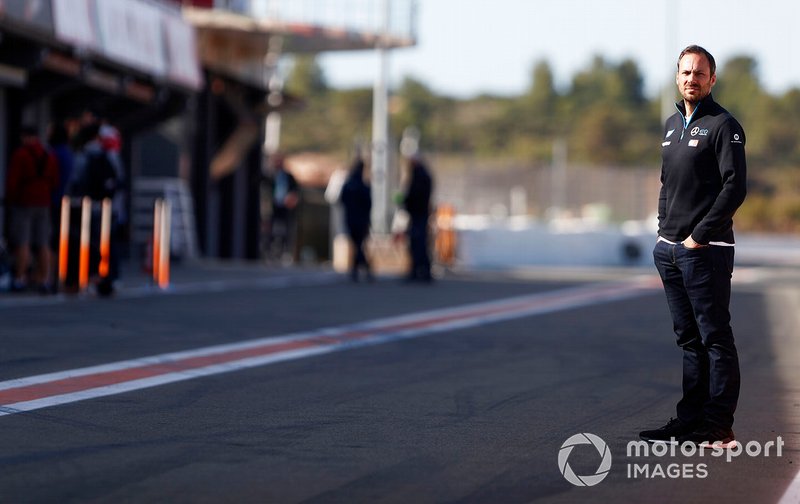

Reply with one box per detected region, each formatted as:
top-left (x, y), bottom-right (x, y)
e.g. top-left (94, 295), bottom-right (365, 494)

top-left (658, 95), bottom-right (747, 244)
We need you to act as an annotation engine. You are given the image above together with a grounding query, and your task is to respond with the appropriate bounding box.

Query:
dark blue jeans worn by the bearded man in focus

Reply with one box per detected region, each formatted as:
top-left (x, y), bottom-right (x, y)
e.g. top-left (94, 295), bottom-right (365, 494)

top-left (653, 241), bottom-right (740, 428)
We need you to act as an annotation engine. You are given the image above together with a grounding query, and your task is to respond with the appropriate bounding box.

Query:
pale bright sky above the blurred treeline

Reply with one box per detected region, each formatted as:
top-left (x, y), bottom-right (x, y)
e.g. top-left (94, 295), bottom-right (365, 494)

top-left (320, 0), bottom-right (800, 97)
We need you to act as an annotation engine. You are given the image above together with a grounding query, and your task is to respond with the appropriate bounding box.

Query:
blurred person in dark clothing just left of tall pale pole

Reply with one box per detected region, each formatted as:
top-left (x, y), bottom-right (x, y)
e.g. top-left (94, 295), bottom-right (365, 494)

top-left (339, 159), bottom-right (372, 282)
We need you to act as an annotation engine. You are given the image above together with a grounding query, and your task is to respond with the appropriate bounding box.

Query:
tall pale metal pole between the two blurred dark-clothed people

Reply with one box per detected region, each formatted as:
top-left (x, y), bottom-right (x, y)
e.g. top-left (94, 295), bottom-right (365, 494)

top-left (371, 0), bottom-right (390, 233)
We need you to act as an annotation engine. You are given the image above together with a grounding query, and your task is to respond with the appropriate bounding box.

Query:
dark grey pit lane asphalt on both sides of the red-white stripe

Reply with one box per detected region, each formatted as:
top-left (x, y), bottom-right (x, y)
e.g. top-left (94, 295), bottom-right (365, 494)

top-left (0, 270), bottom-right (800, 503)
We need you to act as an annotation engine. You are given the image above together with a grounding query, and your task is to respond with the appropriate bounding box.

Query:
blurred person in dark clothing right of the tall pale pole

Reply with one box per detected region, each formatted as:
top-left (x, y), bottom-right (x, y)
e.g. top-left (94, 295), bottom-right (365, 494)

top-left (402, 156), bottom-right (433, 282)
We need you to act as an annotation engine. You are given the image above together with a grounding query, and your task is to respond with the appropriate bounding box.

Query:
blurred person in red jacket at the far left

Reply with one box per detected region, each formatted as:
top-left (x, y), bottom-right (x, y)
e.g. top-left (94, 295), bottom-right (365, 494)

top-left (6, 127), bottom-right (58, 292)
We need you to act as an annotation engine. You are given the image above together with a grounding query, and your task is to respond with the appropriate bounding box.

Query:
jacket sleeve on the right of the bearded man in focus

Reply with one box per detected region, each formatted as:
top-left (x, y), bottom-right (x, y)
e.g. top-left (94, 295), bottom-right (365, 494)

top-left (692, 117), bottom-right (747, 245)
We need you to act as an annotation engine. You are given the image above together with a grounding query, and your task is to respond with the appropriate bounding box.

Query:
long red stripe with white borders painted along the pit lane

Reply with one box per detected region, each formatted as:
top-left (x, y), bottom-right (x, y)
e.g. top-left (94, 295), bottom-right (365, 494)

top-left (0, 276), bottom-right (660, 416)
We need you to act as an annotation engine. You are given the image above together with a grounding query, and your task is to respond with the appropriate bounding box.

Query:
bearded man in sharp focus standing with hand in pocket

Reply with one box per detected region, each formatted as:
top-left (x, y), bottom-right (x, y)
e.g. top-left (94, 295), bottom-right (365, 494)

top-left (639, 45), bottom-right (746, 446)
